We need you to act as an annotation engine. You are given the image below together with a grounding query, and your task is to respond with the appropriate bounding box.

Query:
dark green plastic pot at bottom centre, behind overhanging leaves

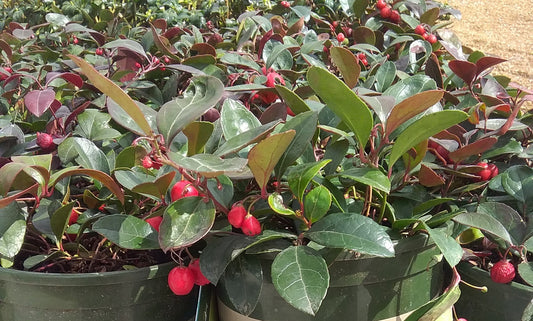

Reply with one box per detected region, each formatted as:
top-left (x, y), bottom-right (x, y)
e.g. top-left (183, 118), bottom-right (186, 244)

top-left (217, 235), bottom-right (445, 321)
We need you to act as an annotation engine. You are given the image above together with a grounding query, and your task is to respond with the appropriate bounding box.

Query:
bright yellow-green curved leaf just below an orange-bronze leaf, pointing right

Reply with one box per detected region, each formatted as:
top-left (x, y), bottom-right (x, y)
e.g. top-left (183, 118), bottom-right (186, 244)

top-left (389, 110), bottom-right (468, 167)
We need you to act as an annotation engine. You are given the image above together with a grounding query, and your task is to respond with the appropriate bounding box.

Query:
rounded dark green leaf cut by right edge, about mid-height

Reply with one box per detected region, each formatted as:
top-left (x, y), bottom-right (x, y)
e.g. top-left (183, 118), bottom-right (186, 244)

top-left (502, 165), bottom-right (533, 204)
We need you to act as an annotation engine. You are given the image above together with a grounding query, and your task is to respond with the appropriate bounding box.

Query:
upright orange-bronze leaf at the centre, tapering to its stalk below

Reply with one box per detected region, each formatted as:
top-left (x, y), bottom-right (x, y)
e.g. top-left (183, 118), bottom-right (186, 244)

top-left (248, 130), bottom-right (296, 198)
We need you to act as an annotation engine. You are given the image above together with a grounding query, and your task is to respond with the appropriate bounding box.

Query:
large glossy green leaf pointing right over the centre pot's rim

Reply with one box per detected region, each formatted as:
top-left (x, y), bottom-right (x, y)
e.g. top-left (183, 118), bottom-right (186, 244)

top-left (305, 213), bottom-right (394, 257)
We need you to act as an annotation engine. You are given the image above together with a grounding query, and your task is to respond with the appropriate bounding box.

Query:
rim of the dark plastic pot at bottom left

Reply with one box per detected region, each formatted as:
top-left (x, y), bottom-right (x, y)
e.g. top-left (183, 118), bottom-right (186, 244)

top-left (0, 261), bottom-right (176, 286)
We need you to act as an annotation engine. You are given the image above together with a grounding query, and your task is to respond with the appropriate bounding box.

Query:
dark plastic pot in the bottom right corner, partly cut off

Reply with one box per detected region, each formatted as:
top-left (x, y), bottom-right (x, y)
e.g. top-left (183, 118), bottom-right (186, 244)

top-left (455, 262), bottom-right (533, 321)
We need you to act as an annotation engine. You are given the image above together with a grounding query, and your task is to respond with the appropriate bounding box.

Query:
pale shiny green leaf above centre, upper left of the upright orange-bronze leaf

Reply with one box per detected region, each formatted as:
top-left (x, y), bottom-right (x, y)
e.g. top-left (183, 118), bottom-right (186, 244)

top-left (220, 99), bottom-right (261, 140)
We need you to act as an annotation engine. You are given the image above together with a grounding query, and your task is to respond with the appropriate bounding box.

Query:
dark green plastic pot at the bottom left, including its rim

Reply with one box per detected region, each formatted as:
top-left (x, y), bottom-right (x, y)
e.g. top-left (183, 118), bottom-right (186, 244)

top-left (0, 263), bottom-right (197, 321)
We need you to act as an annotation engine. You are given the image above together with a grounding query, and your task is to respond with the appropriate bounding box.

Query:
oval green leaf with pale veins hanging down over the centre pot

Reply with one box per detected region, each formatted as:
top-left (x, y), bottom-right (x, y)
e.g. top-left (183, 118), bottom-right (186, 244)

top-left (271, 246), bottom-right (329, 315)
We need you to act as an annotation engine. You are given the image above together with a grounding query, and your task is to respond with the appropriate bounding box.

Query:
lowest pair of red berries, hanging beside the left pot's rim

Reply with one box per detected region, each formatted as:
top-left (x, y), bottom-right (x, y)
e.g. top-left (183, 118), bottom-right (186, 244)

top-left (168, 259), bottom-right (210, 295)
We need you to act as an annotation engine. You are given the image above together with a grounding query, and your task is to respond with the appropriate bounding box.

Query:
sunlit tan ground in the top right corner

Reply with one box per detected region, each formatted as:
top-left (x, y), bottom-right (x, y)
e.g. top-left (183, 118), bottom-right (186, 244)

top-left (443, 0), bottom-right (533, 89)
